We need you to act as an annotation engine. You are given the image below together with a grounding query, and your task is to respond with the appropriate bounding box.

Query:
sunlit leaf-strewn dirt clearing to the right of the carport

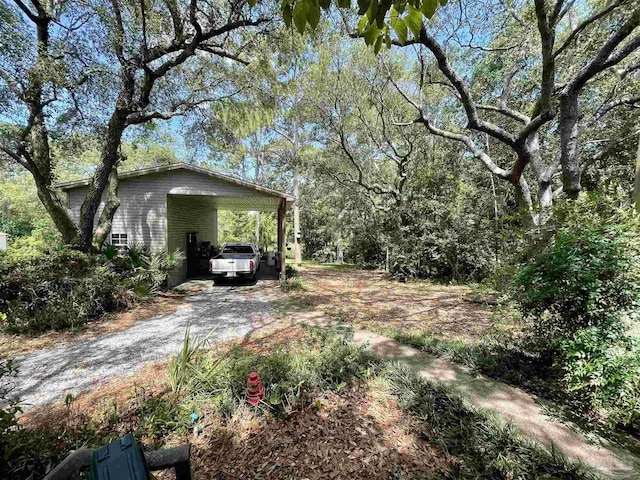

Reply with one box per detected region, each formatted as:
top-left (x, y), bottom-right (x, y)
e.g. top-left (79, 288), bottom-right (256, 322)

top-left (244, 264), bottom-right (493, 340)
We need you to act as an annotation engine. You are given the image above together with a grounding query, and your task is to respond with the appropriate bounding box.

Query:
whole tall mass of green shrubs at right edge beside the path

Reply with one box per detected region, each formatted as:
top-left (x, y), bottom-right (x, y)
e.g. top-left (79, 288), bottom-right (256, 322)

top-left (512, 193), bottom-right (640, 428)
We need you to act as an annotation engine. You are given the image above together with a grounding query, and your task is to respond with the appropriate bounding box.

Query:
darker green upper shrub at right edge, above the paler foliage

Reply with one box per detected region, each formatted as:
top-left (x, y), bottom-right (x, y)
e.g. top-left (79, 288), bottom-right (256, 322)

top-left (513, 195), bottom-right (640, 338)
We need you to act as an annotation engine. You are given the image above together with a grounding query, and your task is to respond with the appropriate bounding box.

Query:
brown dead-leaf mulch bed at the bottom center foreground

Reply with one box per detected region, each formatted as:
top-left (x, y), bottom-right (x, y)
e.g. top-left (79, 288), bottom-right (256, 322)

top-left (192, 385), bottom-right (447, 480)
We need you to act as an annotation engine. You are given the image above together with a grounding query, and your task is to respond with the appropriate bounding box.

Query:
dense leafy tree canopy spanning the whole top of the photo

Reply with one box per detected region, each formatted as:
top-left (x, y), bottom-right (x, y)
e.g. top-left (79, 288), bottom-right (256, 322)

top-left (0, 0), bottom-right (640, 279)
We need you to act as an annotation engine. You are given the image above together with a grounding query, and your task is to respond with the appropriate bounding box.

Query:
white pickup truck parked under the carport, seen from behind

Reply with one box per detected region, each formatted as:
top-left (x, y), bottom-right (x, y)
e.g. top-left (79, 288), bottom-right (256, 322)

top-left (209, 243), bottom-right (260, 280)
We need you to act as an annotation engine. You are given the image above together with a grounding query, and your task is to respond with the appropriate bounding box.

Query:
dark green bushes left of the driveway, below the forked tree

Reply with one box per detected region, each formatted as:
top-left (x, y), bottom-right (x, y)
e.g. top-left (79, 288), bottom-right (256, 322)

top-left (0, 247), bottom-right (183, 333)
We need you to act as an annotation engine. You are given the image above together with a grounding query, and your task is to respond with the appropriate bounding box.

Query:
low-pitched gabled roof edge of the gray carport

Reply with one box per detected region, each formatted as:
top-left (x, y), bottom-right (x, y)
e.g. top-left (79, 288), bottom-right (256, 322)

top-left (55, 162), bottom-right (295, 210)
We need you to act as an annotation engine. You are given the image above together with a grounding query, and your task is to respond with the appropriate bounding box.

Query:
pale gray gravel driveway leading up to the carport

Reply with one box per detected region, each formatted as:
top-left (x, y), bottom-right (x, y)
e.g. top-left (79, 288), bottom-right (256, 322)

top-left (11, 286), bottom-right (271, 408)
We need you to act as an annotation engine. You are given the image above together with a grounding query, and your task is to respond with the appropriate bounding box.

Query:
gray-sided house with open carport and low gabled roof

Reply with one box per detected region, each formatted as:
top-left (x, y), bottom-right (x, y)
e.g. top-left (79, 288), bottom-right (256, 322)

top-left (57, 163), bottom-right (294, 285)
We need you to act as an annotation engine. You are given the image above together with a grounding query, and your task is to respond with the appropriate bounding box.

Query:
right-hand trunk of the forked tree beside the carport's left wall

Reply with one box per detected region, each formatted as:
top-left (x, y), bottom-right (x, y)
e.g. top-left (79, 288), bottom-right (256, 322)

top-left (79, 107), bottom-right (127, 252)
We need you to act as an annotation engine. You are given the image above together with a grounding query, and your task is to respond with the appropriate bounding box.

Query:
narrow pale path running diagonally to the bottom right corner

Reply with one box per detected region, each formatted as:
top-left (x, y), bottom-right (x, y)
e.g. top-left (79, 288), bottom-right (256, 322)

top-left (296, 310), bottom-right (640, 478)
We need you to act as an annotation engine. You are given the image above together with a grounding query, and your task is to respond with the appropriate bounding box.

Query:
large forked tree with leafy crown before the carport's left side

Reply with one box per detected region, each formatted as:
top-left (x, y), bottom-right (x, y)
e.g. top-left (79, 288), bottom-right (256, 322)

top-left (0, 0), bottom-right (269, 250)
